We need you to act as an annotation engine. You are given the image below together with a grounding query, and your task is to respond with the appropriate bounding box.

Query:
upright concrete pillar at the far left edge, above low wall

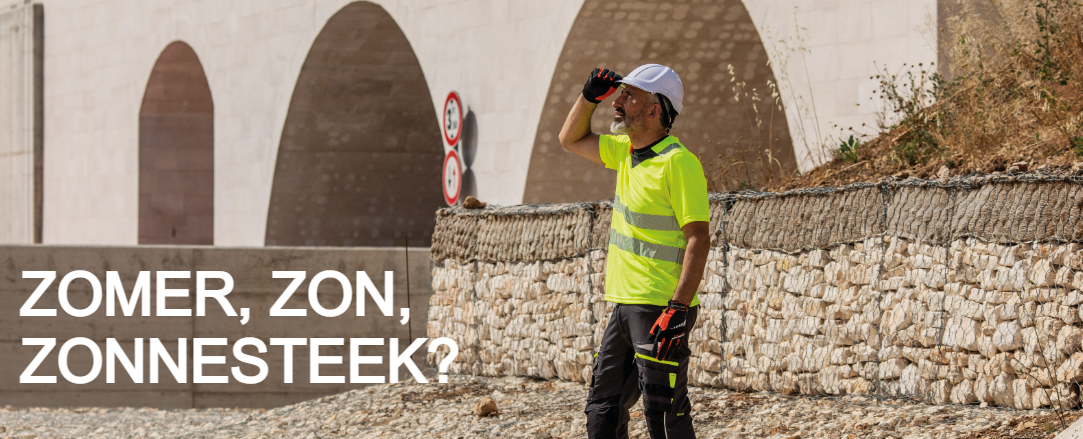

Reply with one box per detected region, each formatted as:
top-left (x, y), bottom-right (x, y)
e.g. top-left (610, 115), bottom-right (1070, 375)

top-left (0, 3), bottom-right (43, 244)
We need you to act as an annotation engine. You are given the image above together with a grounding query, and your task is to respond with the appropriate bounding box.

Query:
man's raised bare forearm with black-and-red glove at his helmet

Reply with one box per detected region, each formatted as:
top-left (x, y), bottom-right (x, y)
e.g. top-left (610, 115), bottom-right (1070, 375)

top-left (557, 68), bottom-right (622, 165)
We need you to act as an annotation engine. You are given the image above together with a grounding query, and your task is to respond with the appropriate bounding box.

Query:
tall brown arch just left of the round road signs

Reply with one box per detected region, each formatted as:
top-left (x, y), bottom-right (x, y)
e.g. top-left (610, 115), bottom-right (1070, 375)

top-left (265, 2), bottom-right (444, 246)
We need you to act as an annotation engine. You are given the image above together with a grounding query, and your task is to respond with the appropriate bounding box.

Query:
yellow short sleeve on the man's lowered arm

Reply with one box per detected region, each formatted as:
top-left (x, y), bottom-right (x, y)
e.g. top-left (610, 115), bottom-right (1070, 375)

top-left (666, 151), bottom-right (710, 228)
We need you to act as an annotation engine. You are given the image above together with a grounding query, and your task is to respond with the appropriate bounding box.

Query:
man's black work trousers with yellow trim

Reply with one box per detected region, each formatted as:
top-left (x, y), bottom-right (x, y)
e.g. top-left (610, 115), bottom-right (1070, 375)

top-left (585, 305), bottom-right (700, 439)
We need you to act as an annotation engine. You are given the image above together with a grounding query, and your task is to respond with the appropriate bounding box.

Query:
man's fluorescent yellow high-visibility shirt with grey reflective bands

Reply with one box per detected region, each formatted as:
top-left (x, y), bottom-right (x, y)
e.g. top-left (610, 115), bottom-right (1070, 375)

top-left (598, 135), bottom-right (710, 307)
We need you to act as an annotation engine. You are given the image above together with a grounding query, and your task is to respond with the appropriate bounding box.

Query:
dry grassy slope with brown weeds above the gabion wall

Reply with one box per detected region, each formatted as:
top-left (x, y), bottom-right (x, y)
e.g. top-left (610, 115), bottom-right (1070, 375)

top-left (770, 0), bottom-right (1083, 190)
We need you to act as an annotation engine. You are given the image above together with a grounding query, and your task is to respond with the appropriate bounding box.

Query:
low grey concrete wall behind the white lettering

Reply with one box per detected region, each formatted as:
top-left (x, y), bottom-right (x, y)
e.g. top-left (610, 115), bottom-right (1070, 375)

top-left (0, 246), bottom-right (430, 408)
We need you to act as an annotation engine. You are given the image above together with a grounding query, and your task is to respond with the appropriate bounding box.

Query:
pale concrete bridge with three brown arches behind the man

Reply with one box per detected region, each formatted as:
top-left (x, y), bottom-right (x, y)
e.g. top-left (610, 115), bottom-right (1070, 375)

top-left (0, 0), bottom-right (941, 246)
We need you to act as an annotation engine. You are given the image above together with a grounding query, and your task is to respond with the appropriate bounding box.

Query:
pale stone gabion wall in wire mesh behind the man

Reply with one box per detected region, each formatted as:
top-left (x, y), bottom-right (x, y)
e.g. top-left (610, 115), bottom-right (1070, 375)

top-left (429, 177), bottom-right (1083, 409)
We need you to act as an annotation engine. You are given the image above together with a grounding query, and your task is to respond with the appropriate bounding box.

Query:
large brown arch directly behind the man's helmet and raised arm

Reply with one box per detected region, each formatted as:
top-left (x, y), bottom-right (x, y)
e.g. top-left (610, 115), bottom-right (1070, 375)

top-left (523, 0), bottom-right (797, 203)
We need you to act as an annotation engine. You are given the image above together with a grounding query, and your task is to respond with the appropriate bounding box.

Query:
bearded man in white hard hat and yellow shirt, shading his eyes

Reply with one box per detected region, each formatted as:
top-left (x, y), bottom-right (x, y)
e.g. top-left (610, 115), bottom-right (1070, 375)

top-left (560, 64), bottom-right (710, 439)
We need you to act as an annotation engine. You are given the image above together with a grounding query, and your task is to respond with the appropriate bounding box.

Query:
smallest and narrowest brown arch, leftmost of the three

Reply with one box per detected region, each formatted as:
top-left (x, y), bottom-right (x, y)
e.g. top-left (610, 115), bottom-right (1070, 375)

top-left (139, 41), bottom-right (214, 245)
